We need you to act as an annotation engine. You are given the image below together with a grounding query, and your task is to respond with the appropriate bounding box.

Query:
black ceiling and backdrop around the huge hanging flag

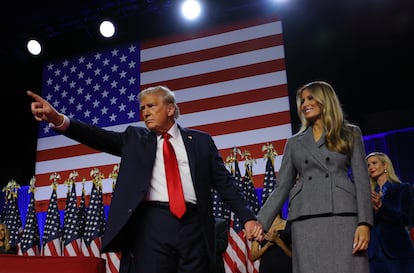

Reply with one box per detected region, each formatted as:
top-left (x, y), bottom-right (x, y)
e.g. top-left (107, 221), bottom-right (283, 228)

top-left (0, 0), bottom-right (414, 185)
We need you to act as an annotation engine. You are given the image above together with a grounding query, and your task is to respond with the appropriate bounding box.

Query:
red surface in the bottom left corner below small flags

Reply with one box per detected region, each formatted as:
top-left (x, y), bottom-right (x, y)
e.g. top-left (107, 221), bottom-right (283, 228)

top-left (0, 254), bottom-right (106, 273)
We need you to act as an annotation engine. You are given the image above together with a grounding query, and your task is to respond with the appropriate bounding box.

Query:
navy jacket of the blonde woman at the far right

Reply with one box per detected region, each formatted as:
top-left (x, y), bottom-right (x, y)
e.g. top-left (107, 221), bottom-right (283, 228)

top-left (368, 182), bottom-right (414, 259)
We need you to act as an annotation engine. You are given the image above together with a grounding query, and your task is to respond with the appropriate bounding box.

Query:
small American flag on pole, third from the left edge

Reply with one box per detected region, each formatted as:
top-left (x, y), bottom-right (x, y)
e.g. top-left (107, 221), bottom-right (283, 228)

top-left (42, 178), bottom-right (62, 256)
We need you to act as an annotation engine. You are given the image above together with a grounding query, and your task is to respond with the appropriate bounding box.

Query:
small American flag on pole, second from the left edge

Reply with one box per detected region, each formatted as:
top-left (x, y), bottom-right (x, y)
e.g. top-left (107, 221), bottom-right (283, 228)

top-left (19, 178), bottom-right (41, 256)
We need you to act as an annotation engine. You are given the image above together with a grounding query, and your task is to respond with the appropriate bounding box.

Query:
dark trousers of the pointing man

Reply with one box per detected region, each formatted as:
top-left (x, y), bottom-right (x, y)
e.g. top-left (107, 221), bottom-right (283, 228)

top-left (120, 203), bottom-right (209, 273)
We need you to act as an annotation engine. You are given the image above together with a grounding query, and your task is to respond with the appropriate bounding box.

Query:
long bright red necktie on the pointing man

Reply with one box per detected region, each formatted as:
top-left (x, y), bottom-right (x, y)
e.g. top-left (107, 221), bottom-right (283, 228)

top-left (162, 133), bottom-right (186, 219)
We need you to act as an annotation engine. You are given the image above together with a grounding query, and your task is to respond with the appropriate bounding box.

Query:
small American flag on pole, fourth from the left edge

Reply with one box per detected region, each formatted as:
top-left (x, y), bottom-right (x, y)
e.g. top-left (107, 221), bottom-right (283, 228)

top-left (63, 172), bottom-right (82, 256)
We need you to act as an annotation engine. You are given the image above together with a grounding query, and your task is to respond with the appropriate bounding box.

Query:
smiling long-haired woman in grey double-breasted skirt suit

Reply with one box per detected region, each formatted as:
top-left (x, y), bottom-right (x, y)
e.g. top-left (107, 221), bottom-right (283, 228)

top-left (258, 81), bottom-right (373, 273)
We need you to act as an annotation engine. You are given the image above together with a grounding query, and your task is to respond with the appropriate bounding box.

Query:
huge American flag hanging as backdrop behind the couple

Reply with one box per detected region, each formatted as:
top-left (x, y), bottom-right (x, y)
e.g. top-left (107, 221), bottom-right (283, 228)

top-left (35, 14), bottom-right (292, 205)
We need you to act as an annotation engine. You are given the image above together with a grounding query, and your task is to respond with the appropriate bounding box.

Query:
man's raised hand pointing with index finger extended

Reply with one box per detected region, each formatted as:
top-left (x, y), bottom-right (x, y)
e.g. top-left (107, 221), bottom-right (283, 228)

top-left (27, 91), bottom-right (64, 126)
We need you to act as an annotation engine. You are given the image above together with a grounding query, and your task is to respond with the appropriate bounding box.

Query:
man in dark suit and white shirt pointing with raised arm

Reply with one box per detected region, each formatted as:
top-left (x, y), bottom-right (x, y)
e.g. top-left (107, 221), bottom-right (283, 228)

top-left (27, 86), bottom-right (263, 273)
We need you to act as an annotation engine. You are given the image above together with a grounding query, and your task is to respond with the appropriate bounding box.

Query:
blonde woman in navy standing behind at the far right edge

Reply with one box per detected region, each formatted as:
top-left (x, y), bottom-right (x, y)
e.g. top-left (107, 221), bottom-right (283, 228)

top-left (366, 152), bottom-right (414, 273)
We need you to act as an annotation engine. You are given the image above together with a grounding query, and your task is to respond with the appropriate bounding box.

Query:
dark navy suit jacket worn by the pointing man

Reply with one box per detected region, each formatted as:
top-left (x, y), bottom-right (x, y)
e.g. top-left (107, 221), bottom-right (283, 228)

top-left (62, 119), bottom-right (256, 262)
